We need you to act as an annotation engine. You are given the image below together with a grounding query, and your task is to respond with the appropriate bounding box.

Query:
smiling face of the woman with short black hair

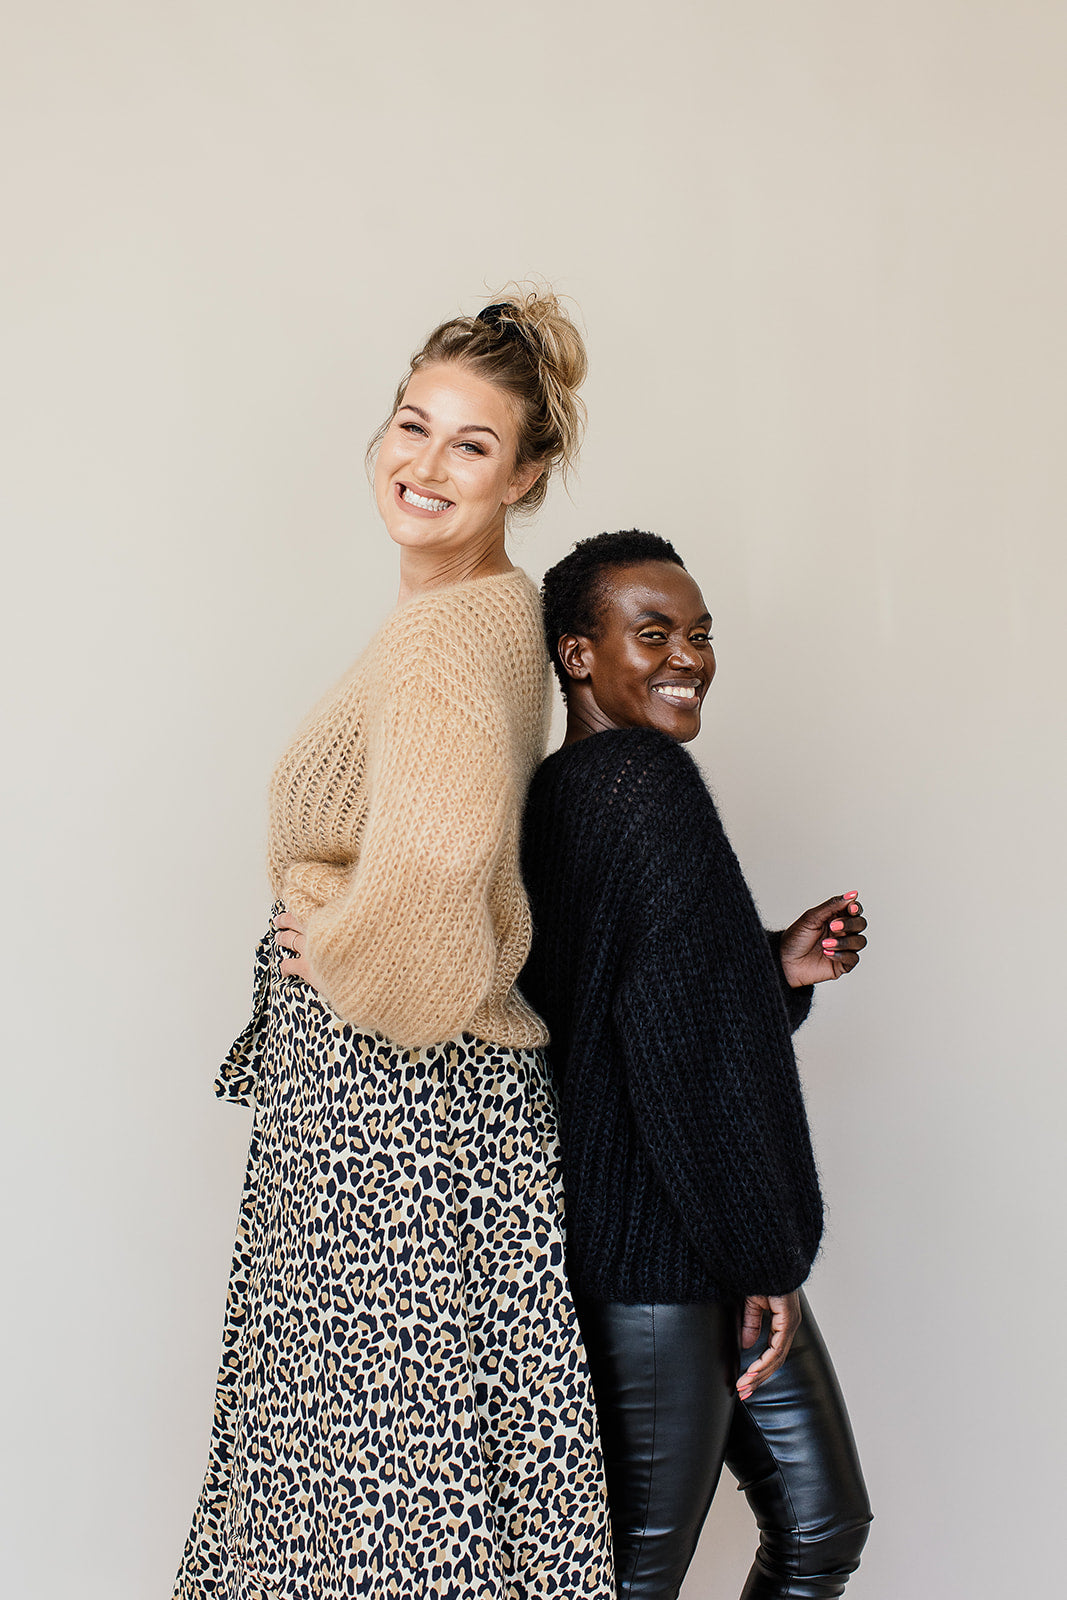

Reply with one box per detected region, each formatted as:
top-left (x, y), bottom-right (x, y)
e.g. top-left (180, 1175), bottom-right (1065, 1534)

top-left (560, 562), bottom-right (715, 742)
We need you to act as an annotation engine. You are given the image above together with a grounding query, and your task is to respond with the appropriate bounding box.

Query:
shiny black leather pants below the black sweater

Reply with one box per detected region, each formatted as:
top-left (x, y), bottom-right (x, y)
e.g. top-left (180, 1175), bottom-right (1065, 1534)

top-left (577, 1296), bottom-right (870, 1600)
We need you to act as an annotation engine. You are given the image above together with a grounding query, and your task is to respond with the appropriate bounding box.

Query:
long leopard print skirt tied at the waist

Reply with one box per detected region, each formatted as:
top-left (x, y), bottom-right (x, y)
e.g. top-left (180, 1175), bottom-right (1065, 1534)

top-left (174, 915), bottom-right (614, 1600)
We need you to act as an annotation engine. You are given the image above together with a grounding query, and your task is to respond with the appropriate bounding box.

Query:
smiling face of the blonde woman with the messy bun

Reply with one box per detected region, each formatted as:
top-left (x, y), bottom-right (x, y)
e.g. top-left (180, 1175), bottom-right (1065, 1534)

top-left (374, 363), bottom-right (539, 555)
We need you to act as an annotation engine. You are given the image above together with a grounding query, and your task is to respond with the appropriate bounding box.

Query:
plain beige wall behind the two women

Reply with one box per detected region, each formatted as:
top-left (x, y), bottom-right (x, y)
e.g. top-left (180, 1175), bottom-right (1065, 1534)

top-left (0, 0), bottom-right (1067, 1600)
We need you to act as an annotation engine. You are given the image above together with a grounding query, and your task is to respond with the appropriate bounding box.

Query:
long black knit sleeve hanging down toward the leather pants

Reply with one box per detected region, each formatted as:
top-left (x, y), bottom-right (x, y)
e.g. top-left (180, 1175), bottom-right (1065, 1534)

top-left (613, 747), bottom-right (822, 1294)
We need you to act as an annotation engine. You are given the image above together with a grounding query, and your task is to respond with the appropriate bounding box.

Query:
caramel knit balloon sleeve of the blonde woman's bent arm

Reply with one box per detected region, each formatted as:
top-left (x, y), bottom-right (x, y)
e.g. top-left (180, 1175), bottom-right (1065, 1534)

top-left (307, 617), bottom-right (517, 1046)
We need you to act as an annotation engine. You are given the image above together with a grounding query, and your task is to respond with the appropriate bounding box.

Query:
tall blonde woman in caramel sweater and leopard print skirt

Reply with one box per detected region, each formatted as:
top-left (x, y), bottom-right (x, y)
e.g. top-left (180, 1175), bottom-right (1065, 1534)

top-left (174, 291), bottom-right (614, 1600)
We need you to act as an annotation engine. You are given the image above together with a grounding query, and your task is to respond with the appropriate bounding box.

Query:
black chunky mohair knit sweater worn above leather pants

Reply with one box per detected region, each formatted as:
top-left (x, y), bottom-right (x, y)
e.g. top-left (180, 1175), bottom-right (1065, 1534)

top-left (520, 728), bottom-right (822, 1304)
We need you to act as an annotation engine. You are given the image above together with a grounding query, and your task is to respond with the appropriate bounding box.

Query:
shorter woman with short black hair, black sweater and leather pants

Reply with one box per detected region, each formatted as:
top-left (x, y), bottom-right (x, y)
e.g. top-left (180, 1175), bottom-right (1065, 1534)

top-left (522, 530), bottom-right (870, 1600)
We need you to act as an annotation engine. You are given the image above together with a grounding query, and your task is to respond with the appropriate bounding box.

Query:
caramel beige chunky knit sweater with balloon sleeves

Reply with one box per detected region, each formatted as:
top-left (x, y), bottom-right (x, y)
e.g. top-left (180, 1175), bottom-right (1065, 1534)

top-left (269, 568), bottom-right (549, 1048)
